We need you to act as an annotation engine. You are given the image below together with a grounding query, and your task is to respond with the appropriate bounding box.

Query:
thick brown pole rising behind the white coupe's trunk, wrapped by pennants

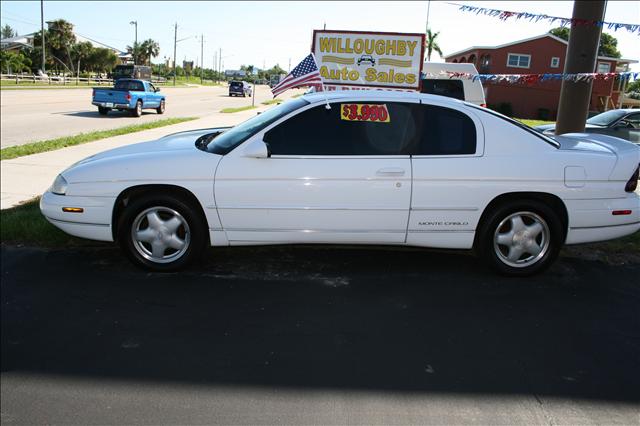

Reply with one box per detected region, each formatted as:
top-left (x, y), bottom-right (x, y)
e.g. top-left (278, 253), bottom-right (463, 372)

top-left (556, 0), bottom-right (607, 135)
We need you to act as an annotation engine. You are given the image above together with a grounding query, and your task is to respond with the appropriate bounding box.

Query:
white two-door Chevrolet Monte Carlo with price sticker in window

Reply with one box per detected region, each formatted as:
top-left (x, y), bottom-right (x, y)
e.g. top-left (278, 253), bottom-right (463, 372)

top-left (40, 91), bottom-right (640, 275)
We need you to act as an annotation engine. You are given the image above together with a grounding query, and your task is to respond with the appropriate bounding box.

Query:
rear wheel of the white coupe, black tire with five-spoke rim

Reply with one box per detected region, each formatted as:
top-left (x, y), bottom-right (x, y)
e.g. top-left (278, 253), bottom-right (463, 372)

top-left (474, 200), bottom-right (565, 276)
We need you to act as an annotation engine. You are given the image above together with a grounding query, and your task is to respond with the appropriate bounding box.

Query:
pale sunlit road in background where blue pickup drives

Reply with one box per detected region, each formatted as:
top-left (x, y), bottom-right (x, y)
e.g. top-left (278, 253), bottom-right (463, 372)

top-left (0, 86), bottom-right (280, 148)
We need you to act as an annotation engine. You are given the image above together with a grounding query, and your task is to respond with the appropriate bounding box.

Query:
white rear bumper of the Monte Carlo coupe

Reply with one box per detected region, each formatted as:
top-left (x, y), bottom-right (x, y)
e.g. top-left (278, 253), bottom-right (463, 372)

top-left (565, 193), bottom-right (640, 244)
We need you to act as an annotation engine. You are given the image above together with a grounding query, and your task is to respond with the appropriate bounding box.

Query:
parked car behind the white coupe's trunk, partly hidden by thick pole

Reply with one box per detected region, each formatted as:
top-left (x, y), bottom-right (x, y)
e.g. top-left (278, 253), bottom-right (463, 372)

top-left (534, 109), bottom-right (640, 144)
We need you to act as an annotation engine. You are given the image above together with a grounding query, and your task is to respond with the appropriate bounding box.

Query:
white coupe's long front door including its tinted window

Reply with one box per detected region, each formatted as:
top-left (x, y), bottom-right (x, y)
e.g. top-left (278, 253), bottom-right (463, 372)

top-left (215, 96), bottom-right (417, 244)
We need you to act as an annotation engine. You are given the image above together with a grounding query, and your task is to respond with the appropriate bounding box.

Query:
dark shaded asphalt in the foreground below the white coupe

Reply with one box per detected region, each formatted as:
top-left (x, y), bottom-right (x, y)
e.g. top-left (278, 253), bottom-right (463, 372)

top-left (0, 245), bottom-right (640, 425)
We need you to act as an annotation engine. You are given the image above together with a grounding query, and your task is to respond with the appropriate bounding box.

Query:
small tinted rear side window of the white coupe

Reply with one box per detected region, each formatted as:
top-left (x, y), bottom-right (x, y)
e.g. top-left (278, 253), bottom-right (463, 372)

top-left (417, 105), bottom-right (476, 155)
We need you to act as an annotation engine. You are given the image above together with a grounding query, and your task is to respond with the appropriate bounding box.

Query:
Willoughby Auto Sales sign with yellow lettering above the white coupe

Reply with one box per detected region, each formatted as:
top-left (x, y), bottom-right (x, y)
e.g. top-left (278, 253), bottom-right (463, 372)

top-left (311, 30), bottom-right (425, 90)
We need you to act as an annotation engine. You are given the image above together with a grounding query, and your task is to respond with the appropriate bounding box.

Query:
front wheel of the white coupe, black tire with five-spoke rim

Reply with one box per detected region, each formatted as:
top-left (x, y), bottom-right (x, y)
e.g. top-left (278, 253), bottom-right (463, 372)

top-left (117, 194), bottom-right (208, 272)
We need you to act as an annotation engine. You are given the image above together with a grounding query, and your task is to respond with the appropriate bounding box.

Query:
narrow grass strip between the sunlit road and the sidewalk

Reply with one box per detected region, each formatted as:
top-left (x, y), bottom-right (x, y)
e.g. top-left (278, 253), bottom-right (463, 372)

top-left (0, 117), bottom-right (198, 160)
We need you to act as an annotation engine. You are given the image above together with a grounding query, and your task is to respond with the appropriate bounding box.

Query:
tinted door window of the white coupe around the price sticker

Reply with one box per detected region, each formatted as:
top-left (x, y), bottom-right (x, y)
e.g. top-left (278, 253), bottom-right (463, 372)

top-left (264, 101), bottom-right (417, 155)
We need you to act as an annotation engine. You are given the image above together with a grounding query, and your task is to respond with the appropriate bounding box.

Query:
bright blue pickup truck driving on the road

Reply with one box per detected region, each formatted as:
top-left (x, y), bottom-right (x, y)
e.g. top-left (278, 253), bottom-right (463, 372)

top-left (91, 78), bottom-right (165, 117)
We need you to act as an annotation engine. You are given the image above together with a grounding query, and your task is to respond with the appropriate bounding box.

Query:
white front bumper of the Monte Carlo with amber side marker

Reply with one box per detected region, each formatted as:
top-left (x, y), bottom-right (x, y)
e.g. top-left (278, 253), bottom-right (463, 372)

top-left (40, 191), bottom-right (116, 241)
